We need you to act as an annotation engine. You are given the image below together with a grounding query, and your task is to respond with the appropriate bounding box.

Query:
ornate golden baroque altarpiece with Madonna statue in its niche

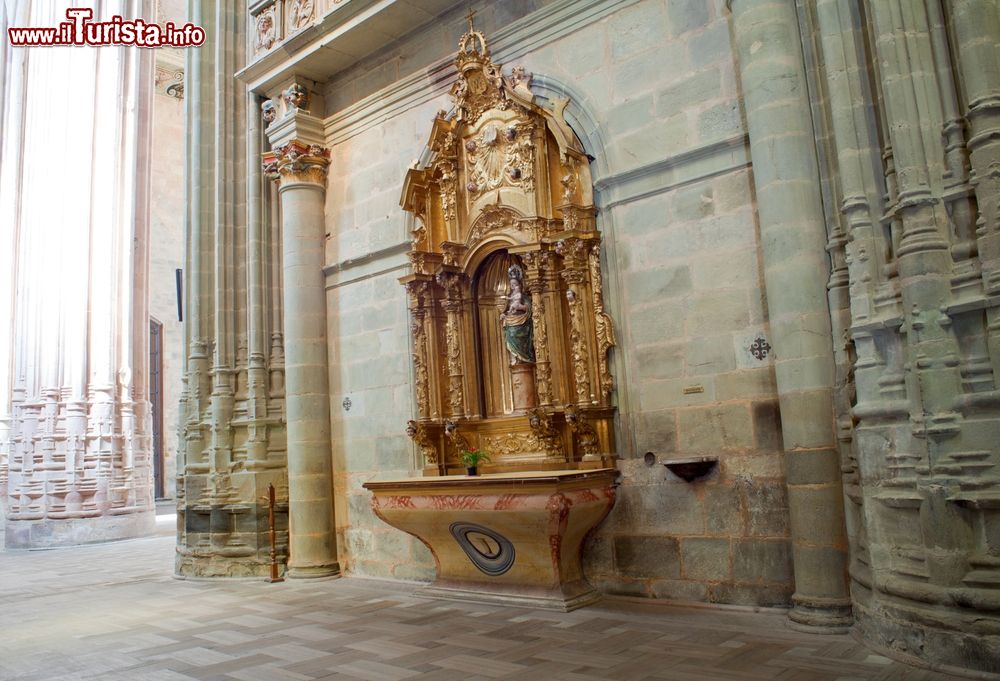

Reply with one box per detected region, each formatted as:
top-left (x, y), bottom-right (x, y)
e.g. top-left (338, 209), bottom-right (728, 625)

top-left (400, 28), bottom-right (615, 475)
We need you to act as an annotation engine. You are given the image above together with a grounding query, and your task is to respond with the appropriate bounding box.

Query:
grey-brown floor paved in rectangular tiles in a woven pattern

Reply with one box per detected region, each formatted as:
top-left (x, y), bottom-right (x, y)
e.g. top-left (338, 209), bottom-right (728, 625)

top-left (0, 525), bottom-right (957, 681)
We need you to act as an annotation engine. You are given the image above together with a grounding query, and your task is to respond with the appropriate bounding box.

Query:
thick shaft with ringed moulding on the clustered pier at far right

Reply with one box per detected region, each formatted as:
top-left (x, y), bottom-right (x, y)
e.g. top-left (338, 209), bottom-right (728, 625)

top-left (870, 0), bottom-right (962, 438)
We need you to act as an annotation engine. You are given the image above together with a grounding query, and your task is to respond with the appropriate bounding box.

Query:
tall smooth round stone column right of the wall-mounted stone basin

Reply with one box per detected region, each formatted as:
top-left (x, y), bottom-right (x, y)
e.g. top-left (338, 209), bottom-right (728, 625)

top-left (730, 0), bottom-right (851, 632)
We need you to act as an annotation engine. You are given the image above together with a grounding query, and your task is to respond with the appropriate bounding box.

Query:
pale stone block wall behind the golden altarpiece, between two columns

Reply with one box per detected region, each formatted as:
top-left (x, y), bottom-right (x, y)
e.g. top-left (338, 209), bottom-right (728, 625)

top-left (318, 1), bottom-right (792, 605)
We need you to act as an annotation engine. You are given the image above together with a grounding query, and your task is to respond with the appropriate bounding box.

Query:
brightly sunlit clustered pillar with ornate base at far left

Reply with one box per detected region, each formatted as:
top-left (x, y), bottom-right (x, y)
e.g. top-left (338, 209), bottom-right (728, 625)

top-left (0, 19), bottom-right (155, 548)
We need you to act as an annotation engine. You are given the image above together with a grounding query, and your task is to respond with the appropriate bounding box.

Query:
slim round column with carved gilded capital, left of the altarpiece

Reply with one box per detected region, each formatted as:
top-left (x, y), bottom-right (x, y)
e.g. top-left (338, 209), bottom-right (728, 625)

top-left (264, 110), bottom-right (340, 578)
